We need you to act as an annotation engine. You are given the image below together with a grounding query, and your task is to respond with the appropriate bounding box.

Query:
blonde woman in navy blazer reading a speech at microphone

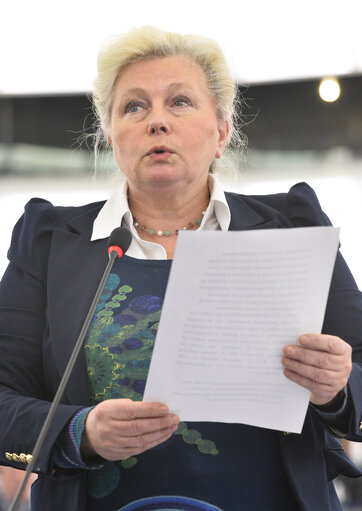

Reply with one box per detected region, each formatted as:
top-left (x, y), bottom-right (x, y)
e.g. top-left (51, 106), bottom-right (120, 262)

top-left (0, 27), bottom-right (362, 511)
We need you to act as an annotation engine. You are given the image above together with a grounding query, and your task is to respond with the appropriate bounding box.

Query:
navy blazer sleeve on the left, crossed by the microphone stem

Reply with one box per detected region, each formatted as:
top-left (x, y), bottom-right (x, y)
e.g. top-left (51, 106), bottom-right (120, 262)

top-left (0, 199), bottom-right (80, 472)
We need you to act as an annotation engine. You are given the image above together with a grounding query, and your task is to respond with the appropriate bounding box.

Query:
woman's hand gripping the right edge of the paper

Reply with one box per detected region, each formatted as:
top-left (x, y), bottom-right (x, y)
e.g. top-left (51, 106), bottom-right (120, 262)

top-left (282, 334), bottom-right (352, 405)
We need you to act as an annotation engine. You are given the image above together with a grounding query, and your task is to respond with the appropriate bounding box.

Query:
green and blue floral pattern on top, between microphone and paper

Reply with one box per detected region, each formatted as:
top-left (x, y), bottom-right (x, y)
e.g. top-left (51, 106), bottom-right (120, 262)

top-left (85, 274), bottom-right (162, 404)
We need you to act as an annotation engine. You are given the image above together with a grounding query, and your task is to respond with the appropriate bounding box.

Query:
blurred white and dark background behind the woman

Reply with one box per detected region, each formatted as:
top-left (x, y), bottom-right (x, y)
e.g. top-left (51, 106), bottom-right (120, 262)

top-left (0, 0), bottom-right (362, 510)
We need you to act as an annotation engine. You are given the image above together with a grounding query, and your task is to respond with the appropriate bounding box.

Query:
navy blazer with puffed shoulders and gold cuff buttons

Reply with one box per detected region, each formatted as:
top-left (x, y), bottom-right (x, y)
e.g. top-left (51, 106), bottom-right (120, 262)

top-left (0, 183), bottom-right (362, 511)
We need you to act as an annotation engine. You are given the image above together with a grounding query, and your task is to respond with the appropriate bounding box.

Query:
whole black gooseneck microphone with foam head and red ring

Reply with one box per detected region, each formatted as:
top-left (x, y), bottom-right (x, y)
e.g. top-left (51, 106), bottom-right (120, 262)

top-left (8, 227), bottom-right (132, 511)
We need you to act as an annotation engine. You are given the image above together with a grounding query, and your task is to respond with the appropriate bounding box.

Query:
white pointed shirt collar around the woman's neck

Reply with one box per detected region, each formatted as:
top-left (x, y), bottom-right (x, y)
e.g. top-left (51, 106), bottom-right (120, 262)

top-left (91, 174), bottom-right (231, 241)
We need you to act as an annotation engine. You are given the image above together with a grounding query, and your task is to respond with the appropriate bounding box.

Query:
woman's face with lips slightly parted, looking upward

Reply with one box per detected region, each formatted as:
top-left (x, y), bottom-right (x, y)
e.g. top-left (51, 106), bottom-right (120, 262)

top-left (108, 55), bottom-right (229, 193)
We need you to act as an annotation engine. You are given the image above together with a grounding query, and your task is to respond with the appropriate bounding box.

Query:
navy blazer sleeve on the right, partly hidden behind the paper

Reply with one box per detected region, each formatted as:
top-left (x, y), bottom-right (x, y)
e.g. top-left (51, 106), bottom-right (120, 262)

top-left (288, 183), bottom-right (362, 441)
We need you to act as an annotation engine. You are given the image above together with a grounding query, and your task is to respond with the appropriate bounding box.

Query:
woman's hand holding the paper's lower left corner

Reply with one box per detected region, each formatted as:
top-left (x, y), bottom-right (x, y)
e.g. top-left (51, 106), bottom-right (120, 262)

top-left (81, 399), bottom-right (180, 461)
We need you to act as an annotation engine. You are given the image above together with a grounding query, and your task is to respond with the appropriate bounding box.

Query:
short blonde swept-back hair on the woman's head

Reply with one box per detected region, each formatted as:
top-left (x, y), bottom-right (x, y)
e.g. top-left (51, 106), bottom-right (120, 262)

top-left (93, 26), bottom-right (244, 174)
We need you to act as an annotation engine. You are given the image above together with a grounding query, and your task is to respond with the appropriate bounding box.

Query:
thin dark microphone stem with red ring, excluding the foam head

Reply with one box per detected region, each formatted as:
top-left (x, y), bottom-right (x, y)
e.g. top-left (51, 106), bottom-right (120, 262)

top-left (8, 251), bottom-right (123, 511)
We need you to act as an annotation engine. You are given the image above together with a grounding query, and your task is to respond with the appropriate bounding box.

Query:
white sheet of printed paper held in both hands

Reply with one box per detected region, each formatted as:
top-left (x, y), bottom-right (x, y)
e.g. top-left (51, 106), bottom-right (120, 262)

top-left (144, 227), bottom-right (339, 433)
